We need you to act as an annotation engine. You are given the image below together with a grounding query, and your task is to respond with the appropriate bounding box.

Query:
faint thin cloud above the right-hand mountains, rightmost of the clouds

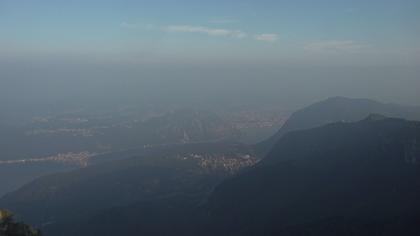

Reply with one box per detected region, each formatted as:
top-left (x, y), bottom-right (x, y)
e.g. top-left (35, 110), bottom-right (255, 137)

top-left (305, 40), bottom-right (368, 53)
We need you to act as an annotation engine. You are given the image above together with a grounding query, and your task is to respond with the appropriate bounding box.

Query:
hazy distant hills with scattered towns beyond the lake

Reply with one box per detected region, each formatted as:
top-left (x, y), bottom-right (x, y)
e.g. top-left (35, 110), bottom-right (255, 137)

top-left (0, 110), bottom-right (241, 160)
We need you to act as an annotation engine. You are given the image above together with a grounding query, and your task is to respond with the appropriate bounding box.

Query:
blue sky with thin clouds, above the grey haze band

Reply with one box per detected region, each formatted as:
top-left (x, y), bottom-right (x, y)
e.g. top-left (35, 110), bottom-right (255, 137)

top-left (0, 0), bottom-right (420, 65)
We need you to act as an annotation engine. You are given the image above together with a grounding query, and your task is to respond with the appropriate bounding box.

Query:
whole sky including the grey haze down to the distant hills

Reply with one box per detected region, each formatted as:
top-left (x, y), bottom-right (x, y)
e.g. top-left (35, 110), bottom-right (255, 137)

top-left (0, 0), bottom-right (420, 113)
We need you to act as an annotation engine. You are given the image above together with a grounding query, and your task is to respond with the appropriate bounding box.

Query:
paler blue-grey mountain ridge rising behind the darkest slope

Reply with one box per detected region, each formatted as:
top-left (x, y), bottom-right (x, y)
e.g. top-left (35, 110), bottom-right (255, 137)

top-left (258, 97), bottom-right (420, 152)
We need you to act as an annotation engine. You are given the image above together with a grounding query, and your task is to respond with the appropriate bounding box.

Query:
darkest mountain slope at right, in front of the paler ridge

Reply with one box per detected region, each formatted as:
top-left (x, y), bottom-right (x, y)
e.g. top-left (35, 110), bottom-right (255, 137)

top-left (207, 115), bottom-right (420, 235)
